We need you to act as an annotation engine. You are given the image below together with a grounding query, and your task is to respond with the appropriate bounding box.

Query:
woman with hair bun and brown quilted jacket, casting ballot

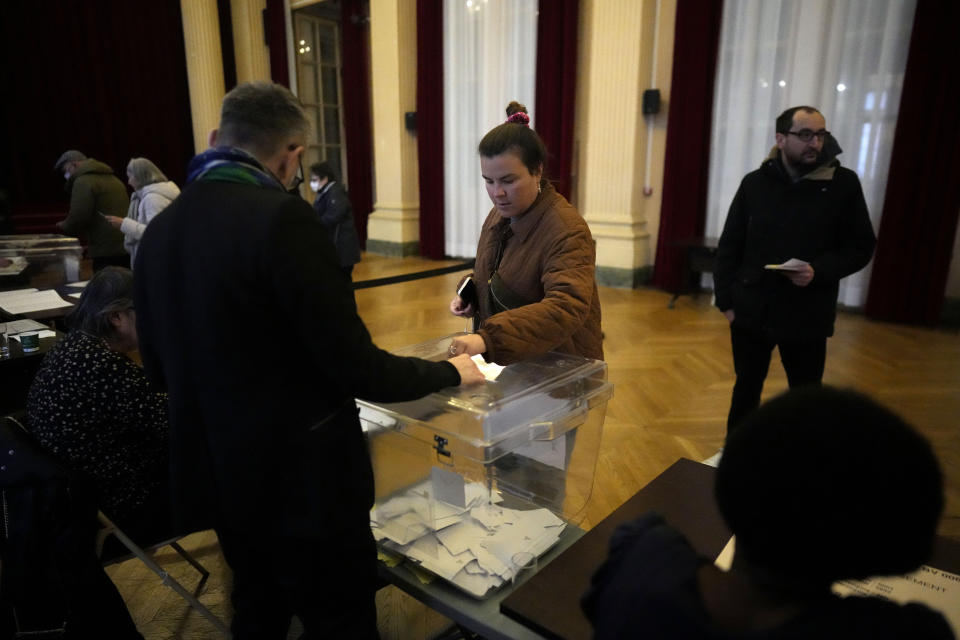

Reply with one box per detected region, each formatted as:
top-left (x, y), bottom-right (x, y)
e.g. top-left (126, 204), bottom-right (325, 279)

top-left (450, 102), bottom-right (603, 365)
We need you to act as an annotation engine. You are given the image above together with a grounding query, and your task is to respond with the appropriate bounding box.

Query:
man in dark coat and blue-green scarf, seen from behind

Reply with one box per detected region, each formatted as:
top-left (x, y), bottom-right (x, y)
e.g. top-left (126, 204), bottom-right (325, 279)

top-left (135, 83), bottom-right (482, 639)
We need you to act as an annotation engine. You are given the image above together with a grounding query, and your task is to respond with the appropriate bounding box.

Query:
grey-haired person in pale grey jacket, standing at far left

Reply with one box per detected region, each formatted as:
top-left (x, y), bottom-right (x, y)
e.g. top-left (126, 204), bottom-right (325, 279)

top-left (104, 158), bottom-right (180, 267)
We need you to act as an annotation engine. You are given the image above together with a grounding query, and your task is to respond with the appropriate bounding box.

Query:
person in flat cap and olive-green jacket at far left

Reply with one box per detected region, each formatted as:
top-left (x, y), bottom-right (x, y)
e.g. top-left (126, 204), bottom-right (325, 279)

top-left (53, 149), bottom-right (130, 272)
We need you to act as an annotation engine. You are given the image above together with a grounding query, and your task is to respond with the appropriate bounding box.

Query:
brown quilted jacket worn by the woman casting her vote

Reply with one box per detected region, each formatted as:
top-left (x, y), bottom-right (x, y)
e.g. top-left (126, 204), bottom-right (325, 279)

top-left (473, 184), bottom-right (603, 365)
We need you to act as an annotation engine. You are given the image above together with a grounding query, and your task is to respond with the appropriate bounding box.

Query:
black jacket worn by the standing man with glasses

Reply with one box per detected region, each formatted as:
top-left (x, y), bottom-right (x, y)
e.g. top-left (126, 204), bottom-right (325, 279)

top-left (714, 154), bottom-right (876, 340)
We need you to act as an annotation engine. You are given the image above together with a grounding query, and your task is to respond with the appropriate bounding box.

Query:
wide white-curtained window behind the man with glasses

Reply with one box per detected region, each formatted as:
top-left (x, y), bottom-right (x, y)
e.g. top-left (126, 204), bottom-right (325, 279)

top-left (706, 0), bottom-right (916, 306)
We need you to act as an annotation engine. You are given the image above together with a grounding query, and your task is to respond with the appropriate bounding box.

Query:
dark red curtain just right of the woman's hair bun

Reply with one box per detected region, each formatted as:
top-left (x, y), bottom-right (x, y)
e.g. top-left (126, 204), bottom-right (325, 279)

top-left (536, 0), bottom-right (580, 199)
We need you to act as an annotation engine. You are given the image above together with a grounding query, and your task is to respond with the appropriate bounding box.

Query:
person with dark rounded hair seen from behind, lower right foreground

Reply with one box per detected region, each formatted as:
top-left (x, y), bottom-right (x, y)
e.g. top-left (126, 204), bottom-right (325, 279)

top-left (582, 387), bottom-right (953, 639)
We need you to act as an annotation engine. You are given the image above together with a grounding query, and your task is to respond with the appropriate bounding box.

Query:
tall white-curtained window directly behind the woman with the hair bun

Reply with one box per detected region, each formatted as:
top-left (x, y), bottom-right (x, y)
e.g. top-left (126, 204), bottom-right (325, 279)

top-left (444, 0), bottom-right (537, 256)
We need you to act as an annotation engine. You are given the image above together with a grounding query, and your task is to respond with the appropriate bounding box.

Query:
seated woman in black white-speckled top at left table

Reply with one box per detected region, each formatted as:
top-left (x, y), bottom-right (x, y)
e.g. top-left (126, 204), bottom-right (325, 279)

top-left (27, 267), bottom-right (170, 544)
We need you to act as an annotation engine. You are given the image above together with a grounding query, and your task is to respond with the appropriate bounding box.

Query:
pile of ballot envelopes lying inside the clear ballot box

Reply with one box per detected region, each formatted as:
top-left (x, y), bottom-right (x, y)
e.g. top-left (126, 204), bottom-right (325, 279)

top-left (370, 468), bottom-right (566, 598)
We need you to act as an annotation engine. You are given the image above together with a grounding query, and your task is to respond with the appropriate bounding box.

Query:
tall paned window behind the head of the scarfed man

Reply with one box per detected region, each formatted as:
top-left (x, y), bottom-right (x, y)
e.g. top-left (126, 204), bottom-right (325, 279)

top-left (294, 10), bottom-right (347, 182)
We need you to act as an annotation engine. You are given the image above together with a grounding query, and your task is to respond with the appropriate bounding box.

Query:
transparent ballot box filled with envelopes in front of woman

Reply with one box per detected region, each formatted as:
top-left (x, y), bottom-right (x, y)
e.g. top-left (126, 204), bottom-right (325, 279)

top-left (357, 337), bottom-right (613, 598)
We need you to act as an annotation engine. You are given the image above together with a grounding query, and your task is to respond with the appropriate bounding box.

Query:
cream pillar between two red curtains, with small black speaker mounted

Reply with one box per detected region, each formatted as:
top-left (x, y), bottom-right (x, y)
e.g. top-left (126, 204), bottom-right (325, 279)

top-left (573, 0), bottom-right (676, 286)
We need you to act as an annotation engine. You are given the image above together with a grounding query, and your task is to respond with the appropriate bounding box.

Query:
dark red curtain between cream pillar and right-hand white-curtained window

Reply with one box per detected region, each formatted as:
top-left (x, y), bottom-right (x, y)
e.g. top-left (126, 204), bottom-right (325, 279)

top-left (651, 0), bottom-right (723, 292)
